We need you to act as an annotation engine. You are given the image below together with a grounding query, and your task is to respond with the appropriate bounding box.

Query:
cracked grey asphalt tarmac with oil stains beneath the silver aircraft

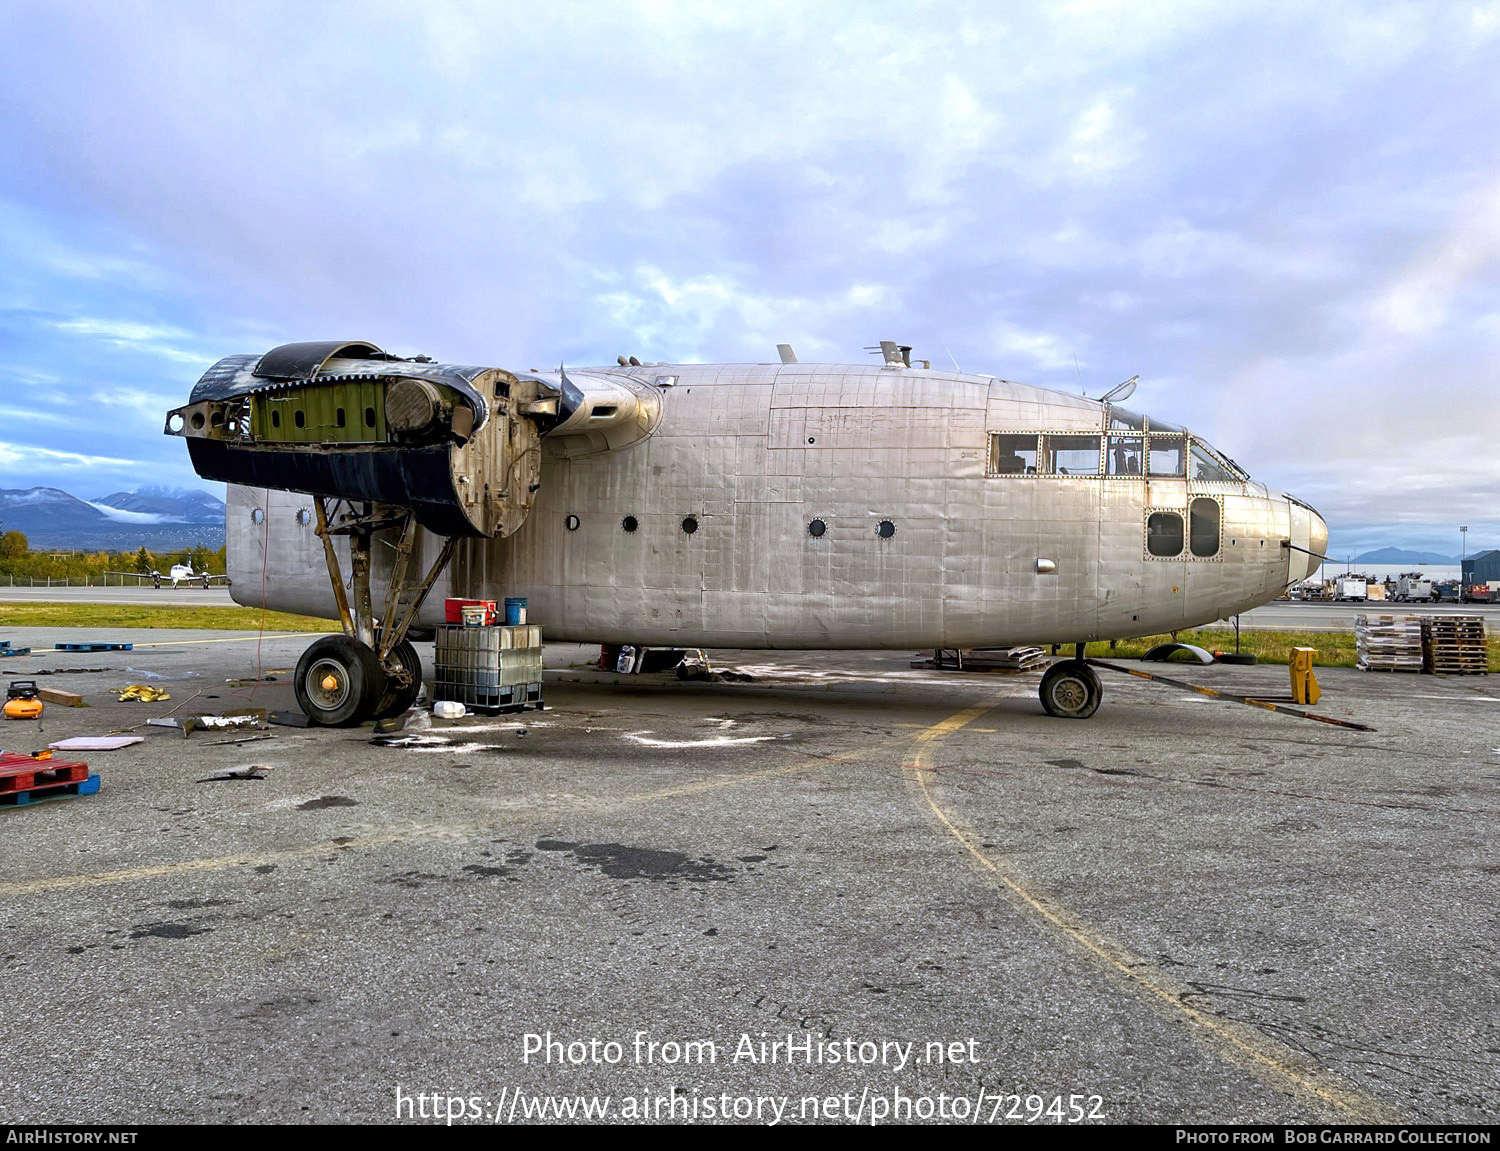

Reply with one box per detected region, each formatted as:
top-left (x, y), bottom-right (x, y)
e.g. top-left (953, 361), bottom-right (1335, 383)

top-left (0, 629), bottom-right (1500, 1124)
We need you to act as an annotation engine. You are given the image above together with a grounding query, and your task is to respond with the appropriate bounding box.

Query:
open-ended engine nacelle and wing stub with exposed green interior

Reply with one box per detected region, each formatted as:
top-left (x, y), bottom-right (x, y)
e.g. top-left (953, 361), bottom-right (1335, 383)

top-left (165, 342), bottom-right (561, 537)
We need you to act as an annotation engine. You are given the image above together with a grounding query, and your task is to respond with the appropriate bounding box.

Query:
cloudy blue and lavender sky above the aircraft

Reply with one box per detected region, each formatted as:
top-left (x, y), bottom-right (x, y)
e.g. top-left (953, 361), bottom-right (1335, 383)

top-left (0, 0), bottom-right (1500, 555)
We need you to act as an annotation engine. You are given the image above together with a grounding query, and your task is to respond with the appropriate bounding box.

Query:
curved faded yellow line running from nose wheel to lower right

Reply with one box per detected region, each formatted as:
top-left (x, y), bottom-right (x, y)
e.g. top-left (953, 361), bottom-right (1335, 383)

top-left (903, 699), bottom-right (1403, 1124)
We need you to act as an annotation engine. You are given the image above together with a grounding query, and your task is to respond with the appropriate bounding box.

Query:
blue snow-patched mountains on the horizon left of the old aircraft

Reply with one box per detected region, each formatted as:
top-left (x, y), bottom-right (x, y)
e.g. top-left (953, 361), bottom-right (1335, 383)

top-left (0, 486), bottom-right (224, 551)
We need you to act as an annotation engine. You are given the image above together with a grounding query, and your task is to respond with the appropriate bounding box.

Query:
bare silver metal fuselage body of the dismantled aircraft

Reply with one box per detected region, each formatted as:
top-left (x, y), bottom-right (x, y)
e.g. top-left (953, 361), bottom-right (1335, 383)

top-left (228, 365), bottom-right (1328, 648)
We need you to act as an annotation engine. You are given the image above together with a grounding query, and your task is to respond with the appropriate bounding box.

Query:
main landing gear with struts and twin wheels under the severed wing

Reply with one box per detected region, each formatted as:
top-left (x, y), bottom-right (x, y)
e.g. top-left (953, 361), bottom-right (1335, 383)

top-left (293, 498), bottom-right (456, 728)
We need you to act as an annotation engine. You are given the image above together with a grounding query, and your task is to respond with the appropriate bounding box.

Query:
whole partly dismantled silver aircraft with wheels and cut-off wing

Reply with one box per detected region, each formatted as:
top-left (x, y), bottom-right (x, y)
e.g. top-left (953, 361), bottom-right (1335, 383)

top-left (165, 342), bottom-right (1328, 725)
